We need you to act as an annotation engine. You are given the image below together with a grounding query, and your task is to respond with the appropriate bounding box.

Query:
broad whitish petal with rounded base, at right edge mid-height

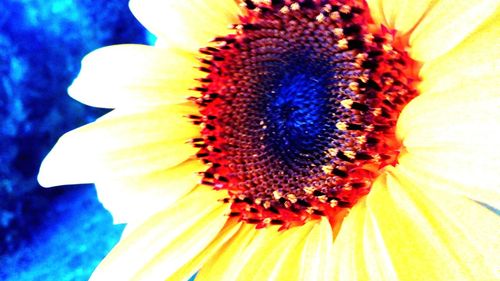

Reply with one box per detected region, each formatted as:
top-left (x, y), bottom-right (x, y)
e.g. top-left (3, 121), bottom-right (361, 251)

top-left (397, 93), bottom-right (500, 206)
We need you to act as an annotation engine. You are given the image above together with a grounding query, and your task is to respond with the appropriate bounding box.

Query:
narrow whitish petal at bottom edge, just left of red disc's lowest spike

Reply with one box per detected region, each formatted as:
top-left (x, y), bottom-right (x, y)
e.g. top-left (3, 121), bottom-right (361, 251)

top-left (298, 217), bottom-right (333, 280)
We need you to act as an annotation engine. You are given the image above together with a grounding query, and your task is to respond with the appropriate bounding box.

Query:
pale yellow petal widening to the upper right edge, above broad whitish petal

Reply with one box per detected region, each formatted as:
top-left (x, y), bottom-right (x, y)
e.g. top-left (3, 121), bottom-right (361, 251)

top-left (418, 9), bottom-right (500, 95)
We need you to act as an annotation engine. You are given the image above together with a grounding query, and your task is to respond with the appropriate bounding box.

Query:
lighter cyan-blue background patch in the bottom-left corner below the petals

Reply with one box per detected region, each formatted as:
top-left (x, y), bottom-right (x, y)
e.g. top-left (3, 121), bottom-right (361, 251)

top-left (0, 186), bottom-right (123, 281)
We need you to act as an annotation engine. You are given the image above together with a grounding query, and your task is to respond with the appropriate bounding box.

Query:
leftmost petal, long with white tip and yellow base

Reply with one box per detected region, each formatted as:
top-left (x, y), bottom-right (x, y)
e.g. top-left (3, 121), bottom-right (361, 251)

top-left (38, 105), bottom-right (198, 186)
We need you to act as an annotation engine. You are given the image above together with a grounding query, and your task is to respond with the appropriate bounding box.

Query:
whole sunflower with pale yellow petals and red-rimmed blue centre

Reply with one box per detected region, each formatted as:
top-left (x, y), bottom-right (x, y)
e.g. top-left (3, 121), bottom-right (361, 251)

top-left (39, 0), bottom-right (500, 280)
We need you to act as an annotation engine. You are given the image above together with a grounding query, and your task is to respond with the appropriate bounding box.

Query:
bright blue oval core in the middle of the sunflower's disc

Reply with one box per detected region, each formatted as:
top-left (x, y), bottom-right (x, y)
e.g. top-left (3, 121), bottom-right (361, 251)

top-left (266, 69), bottom-right (329, 164)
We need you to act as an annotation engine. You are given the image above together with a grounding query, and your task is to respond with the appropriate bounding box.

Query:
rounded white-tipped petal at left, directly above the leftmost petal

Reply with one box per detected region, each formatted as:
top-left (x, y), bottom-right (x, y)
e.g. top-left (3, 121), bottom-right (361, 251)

top-left (68, 45), bottom-right (203, 108)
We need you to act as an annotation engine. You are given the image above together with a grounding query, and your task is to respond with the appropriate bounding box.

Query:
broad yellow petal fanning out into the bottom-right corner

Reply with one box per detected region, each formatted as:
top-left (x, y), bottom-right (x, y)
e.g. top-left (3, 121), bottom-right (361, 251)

top-left (367, 169), bottom-right (500, 281)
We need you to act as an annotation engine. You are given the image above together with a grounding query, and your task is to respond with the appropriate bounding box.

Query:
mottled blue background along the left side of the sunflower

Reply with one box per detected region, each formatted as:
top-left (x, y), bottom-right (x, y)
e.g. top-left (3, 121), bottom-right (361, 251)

top-left (0, 0), bottom-right (150, 280)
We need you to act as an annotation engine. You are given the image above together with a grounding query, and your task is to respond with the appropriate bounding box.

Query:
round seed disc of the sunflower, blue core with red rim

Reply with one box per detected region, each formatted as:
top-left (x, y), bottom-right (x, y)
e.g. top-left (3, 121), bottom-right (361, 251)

top-left (190, 0), bottom-right (417, 229)
